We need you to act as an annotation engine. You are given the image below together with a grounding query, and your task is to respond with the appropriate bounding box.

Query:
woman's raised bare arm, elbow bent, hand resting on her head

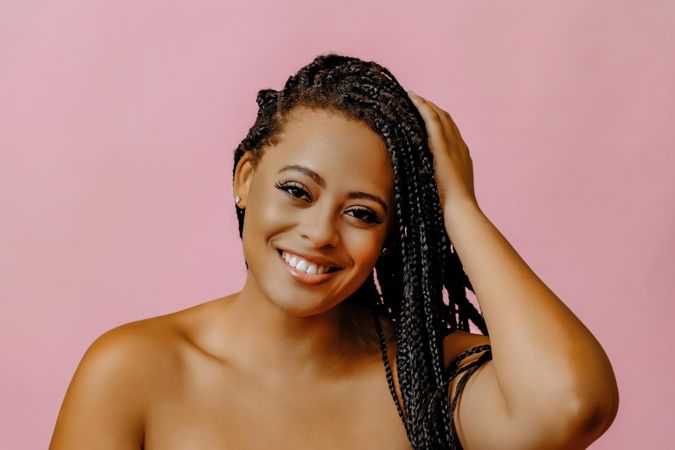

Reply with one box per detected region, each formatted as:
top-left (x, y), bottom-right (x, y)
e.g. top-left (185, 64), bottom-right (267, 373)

top-left (411, 89), bottom-right (618, 450)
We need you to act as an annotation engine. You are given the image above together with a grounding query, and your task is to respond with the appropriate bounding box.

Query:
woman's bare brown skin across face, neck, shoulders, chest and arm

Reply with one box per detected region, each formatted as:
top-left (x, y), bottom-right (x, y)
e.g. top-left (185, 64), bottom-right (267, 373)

top-left (50, 97), bottom-right (615, 450)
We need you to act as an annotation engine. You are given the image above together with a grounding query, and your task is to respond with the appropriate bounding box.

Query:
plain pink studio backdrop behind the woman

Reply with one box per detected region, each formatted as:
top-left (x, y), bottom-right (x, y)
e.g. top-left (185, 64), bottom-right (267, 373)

top-left (0, 0), bottom-right (675, 450)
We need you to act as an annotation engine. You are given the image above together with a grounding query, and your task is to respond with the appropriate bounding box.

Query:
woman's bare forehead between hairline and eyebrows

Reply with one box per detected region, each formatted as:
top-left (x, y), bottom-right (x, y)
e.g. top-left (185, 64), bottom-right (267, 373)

top-left (263, 107), bottom-right (393, 195)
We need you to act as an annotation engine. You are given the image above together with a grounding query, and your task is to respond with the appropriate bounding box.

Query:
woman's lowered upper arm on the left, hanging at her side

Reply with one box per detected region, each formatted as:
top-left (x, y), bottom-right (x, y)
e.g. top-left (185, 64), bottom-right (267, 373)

top-left (49, 324), bottom-right (156, 450)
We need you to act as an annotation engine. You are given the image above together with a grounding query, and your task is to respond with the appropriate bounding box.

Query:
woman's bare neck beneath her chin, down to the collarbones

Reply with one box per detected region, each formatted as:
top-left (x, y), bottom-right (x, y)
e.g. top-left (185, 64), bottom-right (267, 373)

top-left (220, 272), bottom-right (377, 379)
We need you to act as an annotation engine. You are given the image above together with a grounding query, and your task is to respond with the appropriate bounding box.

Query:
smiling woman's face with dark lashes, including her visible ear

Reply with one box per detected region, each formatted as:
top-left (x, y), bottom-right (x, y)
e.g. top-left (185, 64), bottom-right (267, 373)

top-left (234, 107), bottom-right (394, 317)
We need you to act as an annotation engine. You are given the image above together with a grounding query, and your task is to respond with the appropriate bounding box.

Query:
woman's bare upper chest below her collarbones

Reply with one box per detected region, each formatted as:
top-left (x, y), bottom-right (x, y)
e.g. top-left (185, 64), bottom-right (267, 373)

top-left (144, 356), bottom-right (410, 450)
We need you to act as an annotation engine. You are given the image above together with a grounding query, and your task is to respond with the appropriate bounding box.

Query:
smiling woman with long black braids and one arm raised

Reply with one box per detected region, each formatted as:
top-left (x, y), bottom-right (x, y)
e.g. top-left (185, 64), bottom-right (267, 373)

top-left (50, 54), bottom-right (618, 450)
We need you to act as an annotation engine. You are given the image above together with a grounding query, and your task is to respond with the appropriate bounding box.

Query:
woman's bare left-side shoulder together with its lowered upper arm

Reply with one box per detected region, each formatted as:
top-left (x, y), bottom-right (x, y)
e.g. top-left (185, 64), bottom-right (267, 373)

top-left (50, 316), bottom-right (189, 450)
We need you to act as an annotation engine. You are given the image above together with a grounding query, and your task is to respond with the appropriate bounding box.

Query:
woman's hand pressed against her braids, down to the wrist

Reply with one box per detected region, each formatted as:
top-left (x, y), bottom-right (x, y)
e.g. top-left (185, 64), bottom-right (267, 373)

top-left (407, 91), bottom-right (478, 210)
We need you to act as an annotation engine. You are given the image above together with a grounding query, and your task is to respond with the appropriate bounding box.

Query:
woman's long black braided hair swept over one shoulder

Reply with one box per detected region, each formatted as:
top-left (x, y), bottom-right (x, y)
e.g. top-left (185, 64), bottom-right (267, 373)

top-left (233, 53), bottom-right (488, 449)
